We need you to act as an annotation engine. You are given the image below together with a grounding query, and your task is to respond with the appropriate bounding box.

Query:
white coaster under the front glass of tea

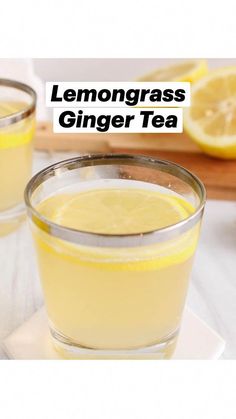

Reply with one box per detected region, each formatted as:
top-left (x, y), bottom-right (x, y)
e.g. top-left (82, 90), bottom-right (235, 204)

top-left (3, 308), bottom-right (225, 360)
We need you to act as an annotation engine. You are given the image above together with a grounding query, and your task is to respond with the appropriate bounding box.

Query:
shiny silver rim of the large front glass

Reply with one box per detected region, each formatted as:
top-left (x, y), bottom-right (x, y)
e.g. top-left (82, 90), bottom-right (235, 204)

top-left (24, 154), bottom-right (206, 247)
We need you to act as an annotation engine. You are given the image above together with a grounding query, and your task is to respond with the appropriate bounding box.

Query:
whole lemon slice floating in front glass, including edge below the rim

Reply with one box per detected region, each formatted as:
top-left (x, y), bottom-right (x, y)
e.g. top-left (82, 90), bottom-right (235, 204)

top-left (36, 188), bottom-right (197, 271)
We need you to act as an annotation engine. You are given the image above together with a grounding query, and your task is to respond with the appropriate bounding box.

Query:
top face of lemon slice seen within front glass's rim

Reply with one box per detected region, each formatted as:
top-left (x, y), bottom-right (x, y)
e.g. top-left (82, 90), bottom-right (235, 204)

top-left (40, 189), bottom-right (193, 234)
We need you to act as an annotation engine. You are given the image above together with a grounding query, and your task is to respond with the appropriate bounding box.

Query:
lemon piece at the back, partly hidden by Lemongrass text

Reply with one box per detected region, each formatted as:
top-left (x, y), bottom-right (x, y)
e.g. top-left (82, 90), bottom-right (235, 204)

top-left (138, 60), bottom-right (208, 82)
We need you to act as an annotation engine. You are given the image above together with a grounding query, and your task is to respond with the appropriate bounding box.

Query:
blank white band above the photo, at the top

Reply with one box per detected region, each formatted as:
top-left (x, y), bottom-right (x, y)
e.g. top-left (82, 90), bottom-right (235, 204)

top-left (0, 0), bottom-right (236, 58)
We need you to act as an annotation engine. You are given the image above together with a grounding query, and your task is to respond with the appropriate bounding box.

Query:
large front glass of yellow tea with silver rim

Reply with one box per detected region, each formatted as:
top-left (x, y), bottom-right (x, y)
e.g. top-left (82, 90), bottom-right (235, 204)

top-left (25, 154), bottom-right (205, 359)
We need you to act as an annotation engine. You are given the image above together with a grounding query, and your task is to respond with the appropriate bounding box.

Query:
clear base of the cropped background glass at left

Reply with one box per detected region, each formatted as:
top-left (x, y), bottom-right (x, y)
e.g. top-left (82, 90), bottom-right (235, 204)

top-left (0, 204), bottom-right (26, 237)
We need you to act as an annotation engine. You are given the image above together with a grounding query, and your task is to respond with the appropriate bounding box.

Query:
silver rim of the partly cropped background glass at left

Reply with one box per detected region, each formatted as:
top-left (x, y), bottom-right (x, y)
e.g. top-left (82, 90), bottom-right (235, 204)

top-left (0, 78), bottom-right (37, 128)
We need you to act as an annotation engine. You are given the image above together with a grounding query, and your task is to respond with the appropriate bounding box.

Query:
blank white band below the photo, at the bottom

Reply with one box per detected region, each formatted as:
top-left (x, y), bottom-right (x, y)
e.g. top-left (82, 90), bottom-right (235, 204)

top-left (0, 361), bottom-right (235, 419)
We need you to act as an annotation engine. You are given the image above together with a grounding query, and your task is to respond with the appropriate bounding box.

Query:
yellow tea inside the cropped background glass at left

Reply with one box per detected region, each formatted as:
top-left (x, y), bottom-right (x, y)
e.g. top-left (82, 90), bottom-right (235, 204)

top-left (0, 102), bottom-right (35, 213)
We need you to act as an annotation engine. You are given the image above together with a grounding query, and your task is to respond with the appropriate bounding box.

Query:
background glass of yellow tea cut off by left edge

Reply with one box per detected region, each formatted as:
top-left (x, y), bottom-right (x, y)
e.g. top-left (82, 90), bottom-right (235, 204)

top-left (0, 79), bottom-right (36, 235)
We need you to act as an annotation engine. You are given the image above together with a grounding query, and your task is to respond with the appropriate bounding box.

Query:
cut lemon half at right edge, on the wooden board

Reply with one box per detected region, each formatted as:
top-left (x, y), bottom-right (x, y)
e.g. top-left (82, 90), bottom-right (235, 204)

top-left (184, 67), bottom-right (236, 159)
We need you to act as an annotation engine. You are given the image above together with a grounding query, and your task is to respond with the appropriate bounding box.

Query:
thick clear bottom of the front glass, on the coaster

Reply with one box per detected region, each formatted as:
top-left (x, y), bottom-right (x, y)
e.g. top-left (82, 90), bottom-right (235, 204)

top-left (50, 328), bottom-right (178, 359)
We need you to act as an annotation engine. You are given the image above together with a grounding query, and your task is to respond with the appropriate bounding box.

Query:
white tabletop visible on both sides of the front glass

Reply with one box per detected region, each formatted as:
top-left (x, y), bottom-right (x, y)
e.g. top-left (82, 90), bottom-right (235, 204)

top-left (0, 153), bottom-right (236, 359)
